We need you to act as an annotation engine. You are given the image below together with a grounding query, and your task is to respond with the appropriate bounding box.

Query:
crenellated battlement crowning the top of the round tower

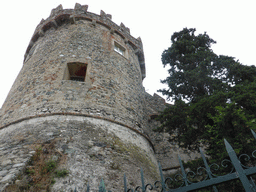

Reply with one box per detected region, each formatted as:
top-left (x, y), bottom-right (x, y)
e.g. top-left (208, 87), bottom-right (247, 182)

top-left (24, 3), bottom-right (145, 78)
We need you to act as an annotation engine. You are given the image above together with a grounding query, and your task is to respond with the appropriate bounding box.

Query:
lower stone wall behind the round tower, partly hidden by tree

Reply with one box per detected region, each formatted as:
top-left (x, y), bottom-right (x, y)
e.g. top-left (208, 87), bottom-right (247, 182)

top-left (145, 93), bottom-right (201, 175)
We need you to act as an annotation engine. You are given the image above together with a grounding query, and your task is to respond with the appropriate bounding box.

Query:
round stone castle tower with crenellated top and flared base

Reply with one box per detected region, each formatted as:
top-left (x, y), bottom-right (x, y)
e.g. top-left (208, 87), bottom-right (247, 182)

top-left (0, 4), bottom-right (158, 192)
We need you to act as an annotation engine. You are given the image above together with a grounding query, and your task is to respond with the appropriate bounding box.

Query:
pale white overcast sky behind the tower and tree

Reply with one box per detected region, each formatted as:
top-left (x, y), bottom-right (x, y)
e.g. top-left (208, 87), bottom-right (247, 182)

top-left (0, 0), bottom-right (256, 106)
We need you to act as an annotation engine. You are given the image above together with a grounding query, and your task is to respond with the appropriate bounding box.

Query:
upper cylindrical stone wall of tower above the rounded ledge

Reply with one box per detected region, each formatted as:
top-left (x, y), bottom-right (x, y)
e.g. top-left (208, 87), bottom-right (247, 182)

top-left (0, 4), bottom-right (144, 135)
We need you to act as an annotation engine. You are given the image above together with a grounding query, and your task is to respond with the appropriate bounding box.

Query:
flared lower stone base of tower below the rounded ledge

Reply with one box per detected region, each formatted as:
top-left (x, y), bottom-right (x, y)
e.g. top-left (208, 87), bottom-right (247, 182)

top-left (0, 115), bottom-right (159, 192)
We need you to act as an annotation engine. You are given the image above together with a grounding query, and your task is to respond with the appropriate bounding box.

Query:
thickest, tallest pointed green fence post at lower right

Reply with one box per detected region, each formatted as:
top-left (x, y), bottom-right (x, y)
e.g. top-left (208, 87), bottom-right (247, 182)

top-left (224, 139), bottom-right (253, 192)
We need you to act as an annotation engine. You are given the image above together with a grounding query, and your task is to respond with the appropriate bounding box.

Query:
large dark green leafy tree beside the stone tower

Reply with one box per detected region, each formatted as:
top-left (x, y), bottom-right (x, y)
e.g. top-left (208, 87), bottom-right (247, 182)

top-left (156, 28), bottom-right (256, 160)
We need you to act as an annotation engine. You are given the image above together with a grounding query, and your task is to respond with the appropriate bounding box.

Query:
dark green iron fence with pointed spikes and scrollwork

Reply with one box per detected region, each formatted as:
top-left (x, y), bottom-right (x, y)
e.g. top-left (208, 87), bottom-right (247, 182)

top-left (75, 130), bottom-right (256, 192)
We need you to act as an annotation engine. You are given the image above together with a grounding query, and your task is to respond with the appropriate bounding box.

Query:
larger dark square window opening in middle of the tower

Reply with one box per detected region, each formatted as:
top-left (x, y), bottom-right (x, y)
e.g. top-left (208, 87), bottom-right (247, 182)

top-left (64, 62), bottom-right (87, 81)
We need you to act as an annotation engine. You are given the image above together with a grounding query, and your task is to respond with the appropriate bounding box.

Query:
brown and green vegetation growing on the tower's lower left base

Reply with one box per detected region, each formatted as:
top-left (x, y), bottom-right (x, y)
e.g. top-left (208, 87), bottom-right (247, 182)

top-left (6, 140), bottom-right (68, 192)
